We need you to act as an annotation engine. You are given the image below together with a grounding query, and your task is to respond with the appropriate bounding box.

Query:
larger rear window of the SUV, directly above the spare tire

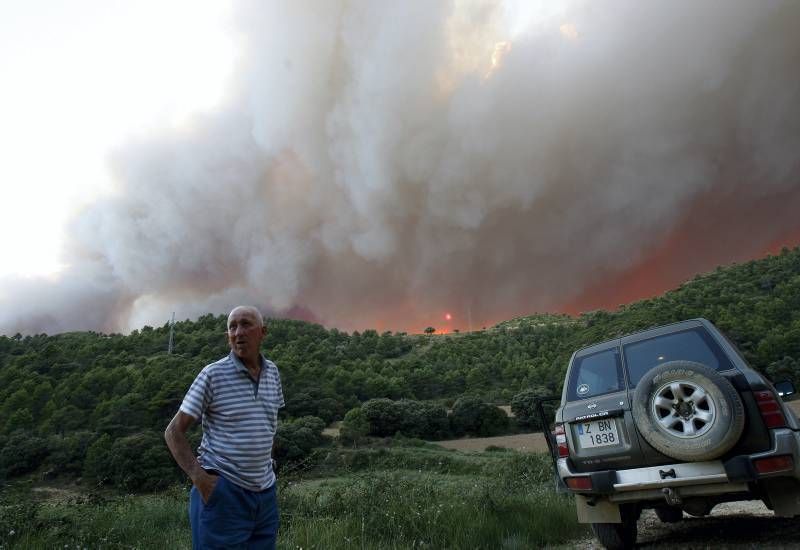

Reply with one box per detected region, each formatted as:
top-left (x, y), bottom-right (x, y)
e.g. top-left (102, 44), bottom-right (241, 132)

top-left (622, 327), bottom-right (733, 387)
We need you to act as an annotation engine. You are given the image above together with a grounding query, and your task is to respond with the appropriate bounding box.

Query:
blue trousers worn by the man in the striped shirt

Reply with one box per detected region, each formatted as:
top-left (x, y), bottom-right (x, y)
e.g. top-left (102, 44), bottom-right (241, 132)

top-left (189, 476), bottom-right (279, 550)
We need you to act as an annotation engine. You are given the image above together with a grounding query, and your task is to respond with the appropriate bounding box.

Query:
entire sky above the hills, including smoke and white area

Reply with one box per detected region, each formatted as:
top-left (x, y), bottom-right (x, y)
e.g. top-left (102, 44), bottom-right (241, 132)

top-left (0, 0), bottom-right (800, 334)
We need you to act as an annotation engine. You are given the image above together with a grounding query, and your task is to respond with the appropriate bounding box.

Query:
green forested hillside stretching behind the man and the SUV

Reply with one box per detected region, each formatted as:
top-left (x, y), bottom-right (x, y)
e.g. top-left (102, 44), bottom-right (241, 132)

top-left (0, 248), bottom-right (800, 488)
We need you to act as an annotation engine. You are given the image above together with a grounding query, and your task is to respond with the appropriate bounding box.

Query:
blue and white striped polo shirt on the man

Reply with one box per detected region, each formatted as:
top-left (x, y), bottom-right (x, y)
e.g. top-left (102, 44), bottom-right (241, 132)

top-left (180, 352), bottom-right (284, 491)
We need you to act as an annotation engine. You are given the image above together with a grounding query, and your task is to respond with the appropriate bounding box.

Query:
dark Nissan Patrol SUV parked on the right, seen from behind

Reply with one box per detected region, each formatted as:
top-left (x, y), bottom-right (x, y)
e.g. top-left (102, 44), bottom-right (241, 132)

top-left (552, 319), bottom-right (800, 548)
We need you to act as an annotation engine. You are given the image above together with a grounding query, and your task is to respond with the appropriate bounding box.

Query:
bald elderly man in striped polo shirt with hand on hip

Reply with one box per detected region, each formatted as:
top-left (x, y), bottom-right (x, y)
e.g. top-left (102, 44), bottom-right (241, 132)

top-left (164, 306), bottom-right (284, 548)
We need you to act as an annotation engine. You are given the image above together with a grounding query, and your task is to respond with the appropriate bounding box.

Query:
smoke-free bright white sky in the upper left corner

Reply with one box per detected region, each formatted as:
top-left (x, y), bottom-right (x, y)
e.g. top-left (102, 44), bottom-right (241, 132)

top-left (0, 0), bottom-right (236, 277)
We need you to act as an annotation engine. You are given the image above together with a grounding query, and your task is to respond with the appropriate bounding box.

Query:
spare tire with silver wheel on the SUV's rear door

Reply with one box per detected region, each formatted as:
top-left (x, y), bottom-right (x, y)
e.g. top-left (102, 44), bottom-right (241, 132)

top-left (632, 361), bottom-right (744, 461)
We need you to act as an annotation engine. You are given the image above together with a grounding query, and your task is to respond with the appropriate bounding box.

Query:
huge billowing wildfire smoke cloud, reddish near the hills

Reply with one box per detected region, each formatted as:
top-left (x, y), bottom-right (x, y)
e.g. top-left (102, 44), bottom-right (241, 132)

top-left (0, 0), bottom-right (800, 333)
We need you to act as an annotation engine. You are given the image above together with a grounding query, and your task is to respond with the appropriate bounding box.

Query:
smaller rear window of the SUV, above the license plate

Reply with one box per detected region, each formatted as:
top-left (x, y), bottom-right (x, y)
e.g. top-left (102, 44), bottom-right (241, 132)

top-left (567, 348), bottom-right (625, 401)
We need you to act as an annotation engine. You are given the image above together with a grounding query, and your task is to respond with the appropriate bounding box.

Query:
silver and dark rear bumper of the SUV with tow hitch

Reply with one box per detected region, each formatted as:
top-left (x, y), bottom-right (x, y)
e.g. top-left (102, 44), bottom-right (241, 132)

top-left (557, 428), bottom-right (800, 502)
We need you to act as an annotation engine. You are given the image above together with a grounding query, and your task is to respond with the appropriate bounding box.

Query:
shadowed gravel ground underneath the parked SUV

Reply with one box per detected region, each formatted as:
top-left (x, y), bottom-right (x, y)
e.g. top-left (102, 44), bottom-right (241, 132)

top-left (574, 501), bottom-right (800, 550)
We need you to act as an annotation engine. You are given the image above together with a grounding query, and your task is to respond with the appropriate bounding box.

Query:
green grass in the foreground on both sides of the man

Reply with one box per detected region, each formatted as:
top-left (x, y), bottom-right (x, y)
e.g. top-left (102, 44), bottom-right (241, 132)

top-left (0, 446), bottom-right (586, 550)
